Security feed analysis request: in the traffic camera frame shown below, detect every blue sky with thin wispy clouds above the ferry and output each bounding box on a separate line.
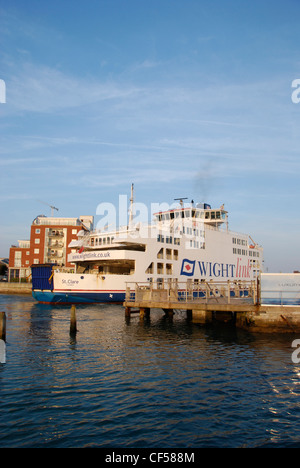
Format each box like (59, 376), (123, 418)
(0, 0), (300, 272)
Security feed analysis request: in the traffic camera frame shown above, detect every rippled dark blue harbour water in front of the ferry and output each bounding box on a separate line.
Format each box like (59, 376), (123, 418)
(0, 295), (300, 449)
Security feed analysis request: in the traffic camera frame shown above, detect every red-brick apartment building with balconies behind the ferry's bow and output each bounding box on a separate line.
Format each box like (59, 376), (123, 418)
(9, 215), (93, 281)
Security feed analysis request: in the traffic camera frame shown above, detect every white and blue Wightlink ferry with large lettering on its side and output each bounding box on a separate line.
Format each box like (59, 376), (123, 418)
(32, 188), (263, 304)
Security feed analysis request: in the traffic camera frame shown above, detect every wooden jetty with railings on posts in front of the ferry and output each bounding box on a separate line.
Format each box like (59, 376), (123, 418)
(124, 280), (300, 333)
